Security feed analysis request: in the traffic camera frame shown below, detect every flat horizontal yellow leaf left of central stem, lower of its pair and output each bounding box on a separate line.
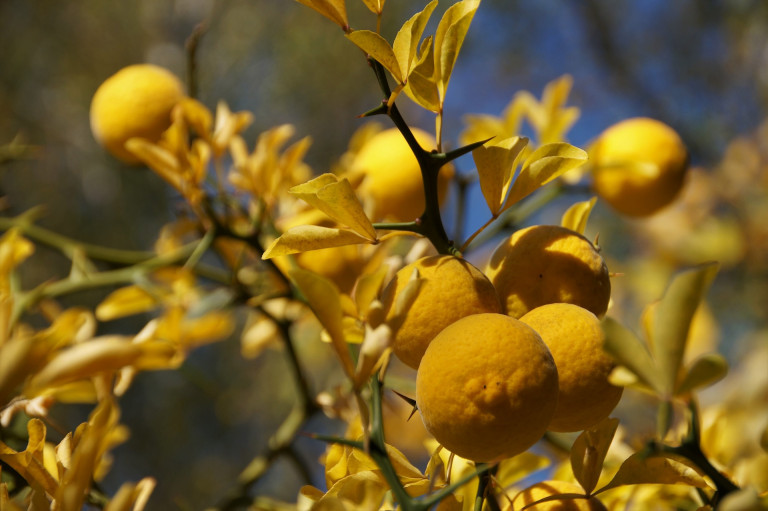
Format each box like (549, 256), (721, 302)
(261, 225), (370, 259)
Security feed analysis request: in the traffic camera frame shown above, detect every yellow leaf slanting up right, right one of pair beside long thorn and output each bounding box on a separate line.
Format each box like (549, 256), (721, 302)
(503, 142), (587, 209)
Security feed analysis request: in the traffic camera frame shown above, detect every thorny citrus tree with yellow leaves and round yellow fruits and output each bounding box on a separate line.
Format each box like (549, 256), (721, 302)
(0, 0), (768, 510)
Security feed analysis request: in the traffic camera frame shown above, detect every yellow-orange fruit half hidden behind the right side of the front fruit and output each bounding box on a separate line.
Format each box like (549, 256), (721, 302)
(520, 303), (624, 432)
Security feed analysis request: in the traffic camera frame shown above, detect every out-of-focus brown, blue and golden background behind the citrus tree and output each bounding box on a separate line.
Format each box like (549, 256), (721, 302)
(0, 0), (768, 509)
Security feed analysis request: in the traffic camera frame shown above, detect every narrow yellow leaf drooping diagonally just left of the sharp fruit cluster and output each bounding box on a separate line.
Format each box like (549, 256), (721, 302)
(289, 269), (355, 378)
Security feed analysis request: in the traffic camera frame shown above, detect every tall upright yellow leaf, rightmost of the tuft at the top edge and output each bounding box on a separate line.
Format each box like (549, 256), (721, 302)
(435, 0), (480, 104)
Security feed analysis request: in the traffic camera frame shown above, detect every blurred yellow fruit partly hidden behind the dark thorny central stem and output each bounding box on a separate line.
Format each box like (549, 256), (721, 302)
(352, 128), (453, 222)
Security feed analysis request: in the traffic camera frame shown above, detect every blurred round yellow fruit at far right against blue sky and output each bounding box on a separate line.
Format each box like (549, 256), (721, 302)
(589, 117), (689, 216)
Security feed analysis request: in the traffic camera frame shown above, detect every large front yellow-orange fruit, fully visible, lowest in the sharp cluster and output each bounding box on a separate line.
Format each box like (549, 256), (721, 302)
(416, 313), (557, 462)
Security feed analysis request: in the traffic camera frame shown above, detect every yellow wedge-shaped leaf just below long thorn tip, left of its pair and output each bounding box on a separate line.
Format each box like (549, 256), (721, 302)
(472, 137), (528, 216)
